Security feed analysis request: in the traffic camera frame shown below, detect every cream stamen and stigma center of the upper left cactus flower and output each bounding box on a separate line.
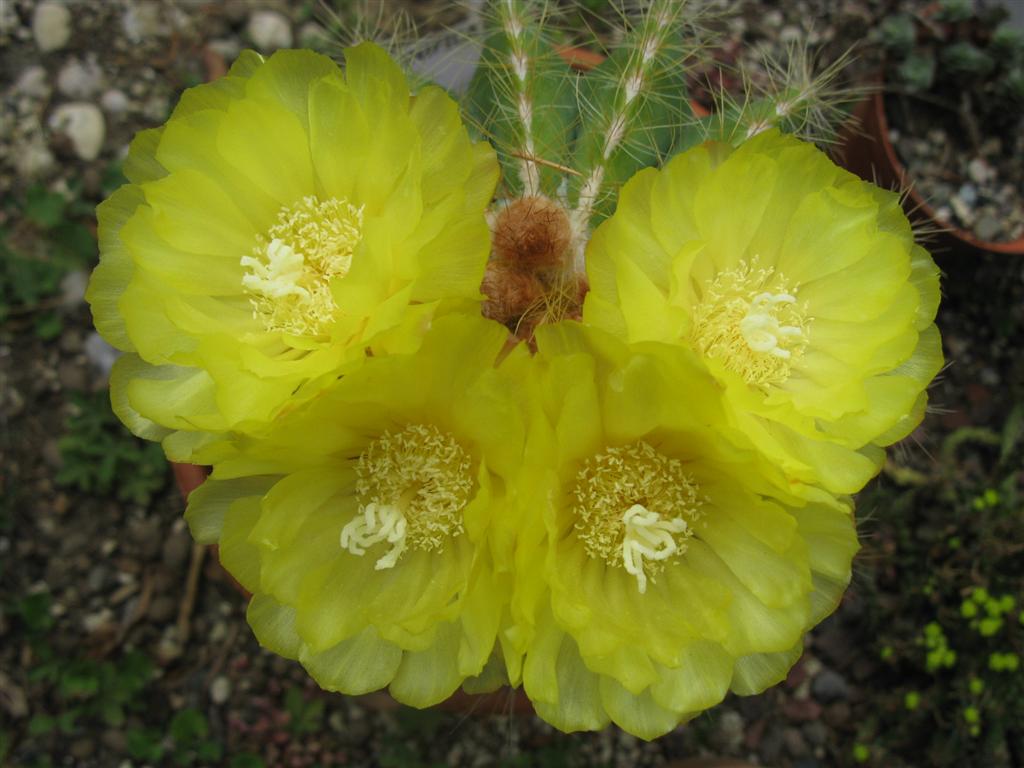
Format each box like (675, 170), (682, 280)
(241, 196), (362, 336)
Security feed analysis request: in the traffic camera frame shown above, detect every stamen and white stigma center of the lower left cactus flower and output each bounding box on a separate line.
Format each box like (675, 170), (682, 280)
(341, 424), (473, 570)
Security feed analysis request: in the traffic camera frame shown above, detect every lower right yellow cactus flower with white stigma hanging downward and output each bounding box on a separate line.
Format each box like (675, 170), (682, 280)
(509, 323), (858, 739)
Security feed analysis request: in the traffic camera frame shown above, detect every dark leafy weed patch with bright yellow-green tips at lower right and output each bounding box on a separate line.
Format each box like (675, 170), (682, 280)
(861, 404), (1024, 765)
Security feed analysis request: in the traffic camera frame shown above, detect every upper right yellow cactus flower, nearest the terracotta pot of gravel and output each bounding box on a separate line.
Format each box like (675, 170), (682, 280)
(584, 131), (942, 494)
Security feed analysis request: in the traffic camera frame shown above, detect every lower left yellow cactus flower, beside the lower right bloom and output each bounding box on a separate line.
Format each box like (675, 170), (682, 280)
(185, 314), (526, 707)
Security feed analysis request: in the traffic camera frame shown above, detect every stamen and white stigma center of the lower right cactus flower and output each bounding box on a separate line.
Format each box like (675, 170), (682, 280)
(572, 440), (702, 594)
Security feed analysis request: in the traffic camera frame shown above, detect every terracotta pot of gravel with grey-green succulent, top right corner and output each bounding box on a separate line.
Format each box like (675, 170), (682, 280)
(847, 0), (1024, 262)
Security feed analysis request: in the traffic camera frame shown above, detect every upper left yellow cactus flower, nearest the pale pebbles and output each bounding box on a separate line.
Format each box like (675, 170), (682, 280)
(88, 43), (498, 450)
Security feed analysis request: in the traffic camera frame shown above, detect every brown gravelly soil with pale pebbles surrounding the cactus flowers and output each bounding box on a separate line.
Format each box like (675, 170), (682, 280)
(0, 0), (1024, 768)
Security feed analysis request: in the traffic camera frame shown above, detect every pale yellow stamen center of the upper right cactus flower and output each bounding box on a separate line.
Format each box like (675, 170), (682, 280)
(692, 257), (810, 386)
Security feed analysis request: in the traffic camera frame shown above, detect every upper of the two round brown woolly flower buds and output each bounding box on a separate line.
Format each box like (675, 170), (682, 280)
(494, 196), (571, 272)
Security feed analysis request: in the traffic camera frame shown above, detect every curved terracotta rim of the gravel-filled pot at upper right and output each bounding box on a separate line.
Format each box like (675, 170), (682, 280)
(840, 91), (1024, 273)
